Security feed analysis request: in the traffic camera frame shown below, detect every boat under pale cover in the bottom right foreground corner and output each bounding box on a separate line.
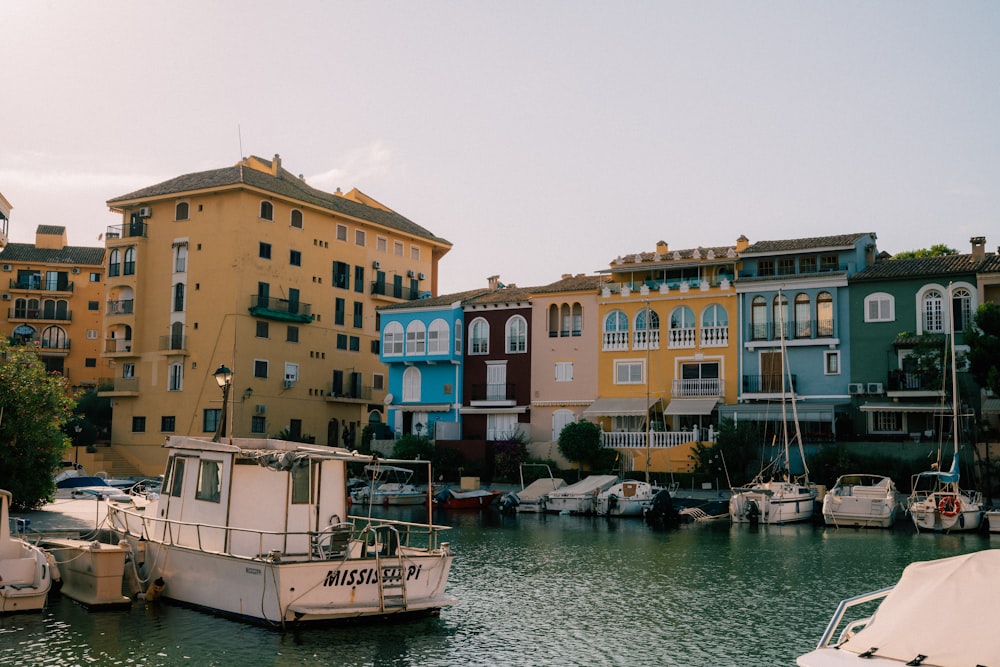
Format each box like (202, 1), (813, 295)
(796, 549), (1000, 667)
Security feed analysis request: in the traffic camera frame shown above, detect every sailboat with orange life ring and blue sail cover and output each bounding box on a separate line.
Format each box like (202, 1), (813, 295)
(906, 288), (983, 531)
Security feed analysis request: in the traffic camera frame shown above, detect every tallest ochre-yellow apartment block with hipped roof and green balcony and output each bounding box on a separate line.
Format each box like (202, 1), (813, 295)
(102, 155), (451, 474)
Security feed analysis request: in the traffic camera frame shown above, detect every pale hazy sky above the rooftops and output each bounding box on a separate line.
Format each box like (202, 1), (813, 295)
(0, 0), (1000, 293)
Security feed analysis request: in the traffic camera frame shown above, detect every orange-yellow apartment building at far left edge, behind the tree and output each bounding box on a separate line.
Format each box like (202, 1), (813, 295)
(0, 217), (104, 389)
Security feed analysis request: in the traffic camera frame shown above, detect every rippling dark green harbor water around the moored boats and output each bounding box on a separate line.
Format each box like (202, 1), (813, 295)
(0, 508), (997, 667)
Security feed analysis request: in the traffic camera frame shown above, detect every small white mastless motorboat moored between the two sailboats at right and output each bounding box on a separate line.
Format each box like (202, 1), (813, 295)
(823, 474), (899, 528)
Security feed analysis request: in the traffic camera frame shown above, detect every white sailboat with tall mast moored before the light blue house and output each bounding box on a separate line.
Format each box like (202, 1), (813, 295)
(729, 292), (817, 524)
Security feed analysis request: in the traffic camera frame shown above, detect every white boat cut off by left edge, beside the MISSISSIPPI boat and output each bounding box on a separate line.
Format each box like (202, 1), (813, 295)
(0, 489), (53, 614)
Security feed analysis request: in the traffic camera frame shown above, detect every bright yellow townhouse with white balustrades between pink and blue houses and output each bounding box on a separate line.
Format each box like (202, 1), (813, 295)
(583, 237), (747, 472)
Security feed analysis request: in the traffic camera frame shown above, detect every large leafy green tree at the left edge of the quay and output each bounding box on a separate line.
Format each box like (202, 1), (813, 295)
(0, 339), (73, 509)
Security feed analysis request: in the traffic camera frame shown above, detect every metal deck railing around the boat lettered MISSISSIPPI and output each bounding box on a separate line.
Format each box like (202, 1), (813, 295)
(108, 507), (450, 562)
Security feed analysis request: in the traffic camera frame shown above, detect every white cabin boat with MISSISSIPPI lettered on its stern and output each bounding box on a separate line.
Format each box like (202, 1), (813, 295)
(108, 436), (455, 627)
